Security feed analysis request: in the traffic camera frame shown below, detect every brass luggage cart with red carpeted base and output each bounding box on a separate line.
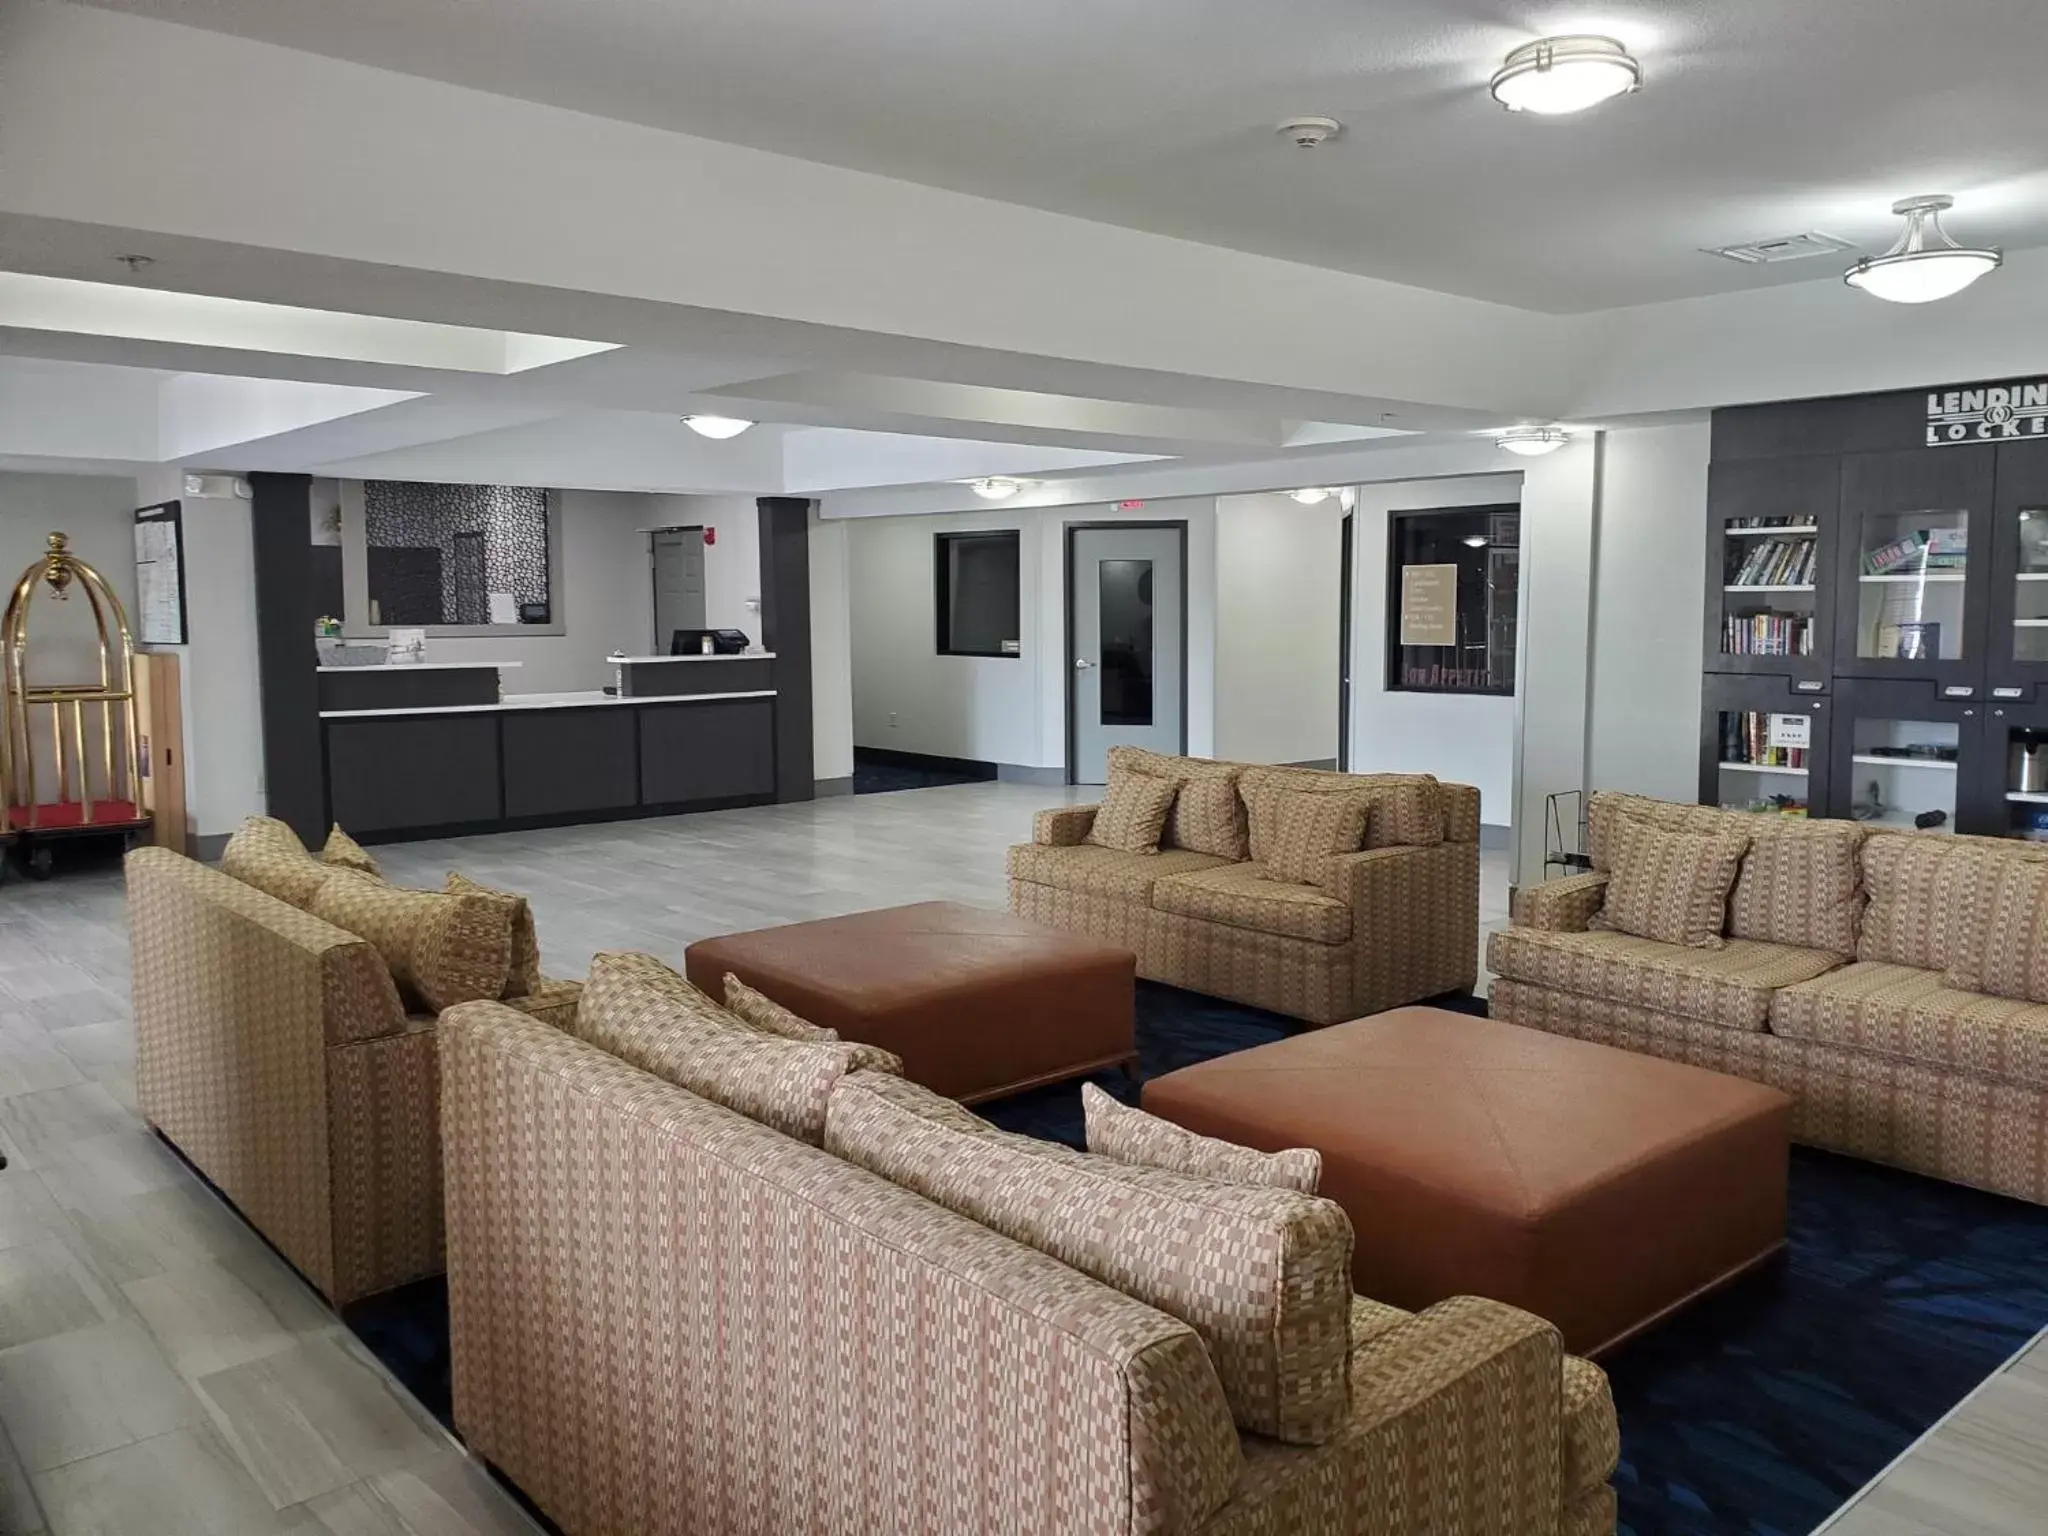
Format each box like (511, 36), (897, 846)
(0, 532), (150, 879)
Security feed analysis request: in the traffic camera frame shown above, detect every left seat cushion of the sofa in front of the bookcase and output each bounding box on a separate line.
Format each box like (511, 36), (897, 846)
(1487, 928), (1841, 1030)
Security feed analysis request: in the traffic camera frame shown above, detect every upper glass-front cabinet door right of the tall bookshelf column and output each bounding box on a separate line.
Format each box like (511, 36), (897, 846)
(1835, 446), (1995, 698)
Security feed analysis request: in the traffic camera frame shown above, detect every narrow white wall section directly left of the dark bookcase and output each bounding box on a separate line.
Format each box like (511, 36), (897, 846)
(1587, 422), (1710, 801)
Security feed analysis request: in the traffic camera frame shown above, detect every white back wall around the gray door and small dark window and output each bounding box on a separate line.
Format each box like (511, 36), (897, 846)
(844, 496), (1217, 770)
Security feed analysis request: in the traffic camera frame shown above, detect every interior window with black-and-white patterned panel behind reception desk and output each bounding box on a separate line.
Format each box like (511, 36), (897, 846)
(362, 479), (551, 625)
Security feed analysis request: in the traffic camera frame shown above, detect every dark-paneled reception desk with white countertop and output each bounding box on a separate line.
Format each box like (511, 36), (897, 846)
(319, 655), (776, 842)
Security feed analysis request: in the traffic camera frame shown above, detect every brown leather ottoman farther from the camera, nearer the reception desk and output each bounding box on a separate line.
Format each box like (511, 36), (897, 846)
(684, 901), (1137, 1104)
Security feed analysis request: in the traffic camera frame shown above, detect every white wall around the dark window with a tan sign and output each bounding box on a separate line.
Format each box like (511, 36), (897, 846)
(1352, 473), (1532, 827)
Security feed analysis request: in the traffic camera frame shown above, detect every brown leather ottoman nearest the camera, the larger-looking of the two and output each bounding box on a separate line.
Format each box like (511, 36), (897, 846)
(1143, 1008), (1792, 1354)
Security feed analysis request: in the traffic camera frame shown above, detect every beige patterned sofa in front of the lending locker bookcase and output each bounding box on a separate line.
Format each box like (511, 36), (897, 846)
(1487, 795), (2048, 1202)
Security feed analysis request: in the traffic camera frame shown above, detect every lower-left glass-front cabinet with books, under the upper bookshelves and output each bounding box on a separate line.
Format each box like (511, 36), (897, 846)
(1700, 676), (1833, 815)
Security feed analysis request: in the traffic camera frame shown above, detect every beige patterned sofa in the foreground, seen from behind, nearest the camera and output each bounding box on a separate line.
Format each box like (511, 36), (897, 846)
(440, 974), (1618, 1536)
